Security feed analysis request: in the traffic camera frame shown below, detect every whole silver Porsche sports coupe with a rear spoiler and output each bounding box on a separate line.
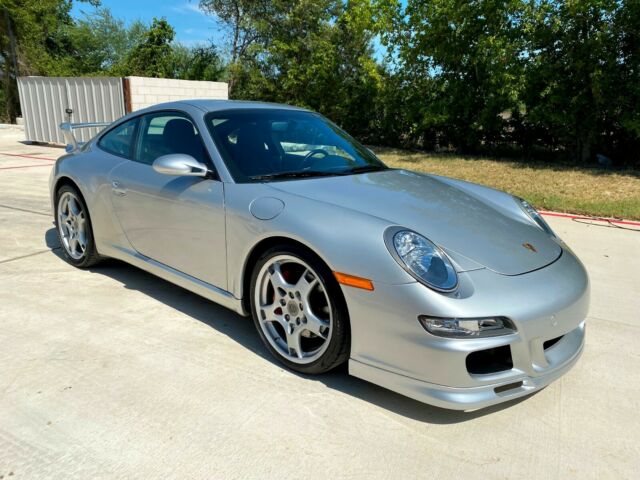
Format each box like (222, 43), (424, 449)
(50, 100), (589, 410)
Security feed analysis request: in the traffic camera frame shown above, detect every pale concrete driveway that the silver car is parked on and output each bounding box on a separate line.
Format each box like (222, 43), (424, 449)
(0, 131), (640, 480)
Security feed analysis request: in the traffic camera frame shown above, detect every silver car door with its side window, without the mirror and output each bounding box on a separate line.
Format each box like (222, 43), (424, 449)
(105, 111), (227, 290)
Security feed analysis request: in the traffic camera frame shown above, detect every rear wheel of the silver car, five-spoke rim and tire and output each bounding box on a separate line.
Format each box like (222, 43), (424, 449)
(55, 185), (100, 268)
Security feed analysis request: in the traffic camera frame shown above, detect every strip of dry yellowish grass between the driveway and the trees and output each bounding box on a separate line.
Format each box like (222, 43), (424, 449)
(373, 147), (640, 220)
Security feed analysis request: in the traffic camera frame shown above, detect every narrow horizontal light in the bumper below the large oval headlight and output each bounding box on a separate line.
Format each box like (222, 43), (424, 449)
(418, 315), (516, 338)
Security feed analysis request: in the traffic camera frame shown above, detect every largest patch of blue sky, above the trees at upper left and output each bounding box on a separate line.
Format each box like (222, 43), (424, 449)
(71, 0), (224, 46)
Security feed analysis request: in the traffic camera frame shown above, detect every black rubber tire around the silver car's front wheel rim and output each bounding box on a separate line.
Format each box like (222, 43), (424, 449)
(248, 245), (351, 375)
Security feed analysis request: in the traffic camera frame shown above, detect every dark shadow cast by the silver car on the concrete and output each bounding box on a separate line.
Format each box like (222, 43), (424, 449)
(45, 229), (528, 424)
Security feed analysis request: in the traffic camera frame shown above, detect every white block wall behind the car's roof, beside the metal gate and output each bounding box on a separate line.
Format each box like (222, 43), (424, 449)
(128, 77), (229, 111)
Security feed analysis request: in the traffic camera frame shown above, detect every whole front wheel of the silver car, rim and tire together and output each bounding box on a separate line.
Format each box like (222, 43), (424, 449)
(250, 246), (350, 374)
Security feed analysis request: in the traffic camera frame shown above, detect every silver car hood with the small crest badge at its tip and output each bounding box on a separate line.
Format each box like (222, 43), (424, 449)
(270, 170), (562, 275)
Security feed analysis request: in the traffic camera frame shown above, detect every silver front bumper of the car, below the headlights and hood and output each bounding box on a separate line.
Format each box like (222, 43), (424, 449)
(343, 250), (589, 410)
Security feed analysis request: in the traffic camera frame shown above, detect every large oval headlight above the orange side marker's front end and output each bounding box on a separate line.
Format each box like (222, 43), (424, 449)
(385, 228), (458, 292)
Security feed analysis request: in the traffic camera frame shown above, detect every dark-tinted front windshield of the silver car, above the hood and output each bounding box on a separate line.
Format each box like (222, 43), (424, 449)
(206, 109), (387, 182)
